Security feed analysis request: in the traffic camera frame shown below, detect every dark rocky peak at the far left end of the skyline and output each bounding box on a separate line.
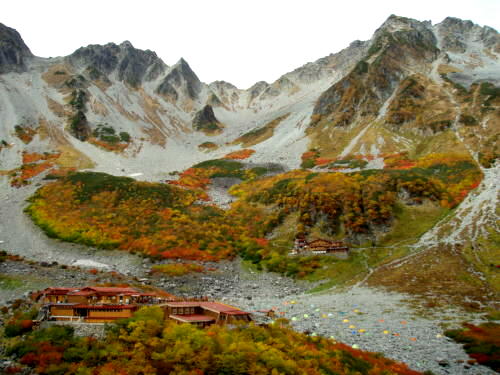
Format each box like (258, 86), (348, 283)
(0, 23), (33, 74)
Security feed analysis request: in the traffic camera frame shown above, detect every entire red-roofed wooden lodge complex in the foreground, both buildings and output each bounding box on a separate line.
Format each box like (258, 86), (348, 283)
(33, 287), (252, 327)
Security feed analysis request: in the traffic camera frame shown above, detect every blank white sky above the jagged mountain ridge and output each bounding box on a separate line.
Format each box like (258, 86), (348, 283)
(0, 0), (500, 88)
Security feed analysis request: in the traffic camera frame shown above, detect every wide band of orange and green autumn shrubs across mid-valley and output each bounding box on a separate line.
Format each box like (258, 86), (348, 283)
(26, 154), (482, 277)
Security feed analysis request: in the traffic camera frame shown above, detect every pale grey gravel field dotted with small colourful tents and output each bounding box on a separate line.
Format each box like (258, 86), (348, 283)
(231, 286), (494, 375)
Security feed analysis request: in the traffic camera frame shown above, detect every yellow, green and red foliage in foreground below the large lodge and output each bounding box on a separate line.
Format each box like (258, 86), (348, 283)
(5, 307), (420, 375)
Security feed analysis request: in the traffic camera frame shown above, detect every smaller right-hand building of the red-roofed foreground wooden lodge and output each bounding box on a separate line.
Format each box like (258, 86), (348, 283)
(161, 301), (252, 327)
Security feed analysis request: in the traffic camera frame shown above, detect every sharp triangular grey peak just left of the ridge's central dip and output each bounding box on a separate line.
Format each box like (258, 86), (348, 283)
(156, 58), (202, 101)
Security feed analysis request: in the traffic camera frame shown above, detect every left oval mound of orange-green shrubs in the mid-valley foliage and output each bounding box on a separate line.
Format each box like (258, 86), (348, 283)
(26, 172), (261, 261)
